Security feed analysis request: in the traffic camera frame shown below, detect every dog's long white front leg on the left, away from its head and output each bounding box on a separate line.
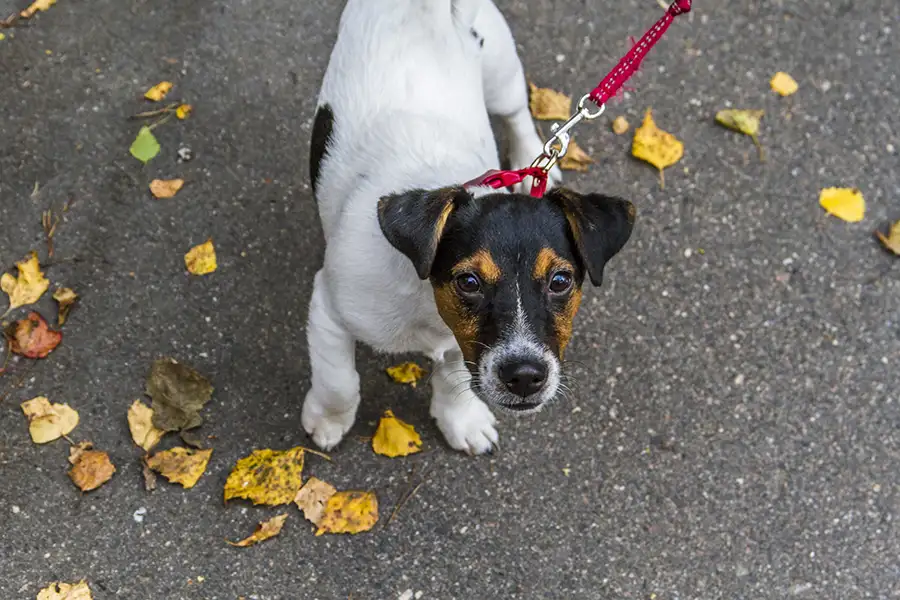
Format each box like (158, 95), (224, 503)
(302, 271), (359, 450)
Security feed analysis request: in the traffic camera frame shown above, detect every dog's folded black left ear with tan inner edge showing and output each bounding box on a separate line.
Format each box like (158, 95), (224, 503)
(378, 187), (472, 279)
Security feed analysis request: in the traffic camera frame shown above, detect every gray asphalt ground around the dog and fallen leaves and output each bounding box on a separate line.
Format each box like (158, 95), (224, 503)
(0, 0), (900, 600)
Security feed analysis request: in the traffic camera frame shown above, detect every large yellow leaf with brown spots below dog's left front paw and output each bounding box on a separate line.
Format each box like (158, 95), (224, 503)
(225, 446), (303, 506)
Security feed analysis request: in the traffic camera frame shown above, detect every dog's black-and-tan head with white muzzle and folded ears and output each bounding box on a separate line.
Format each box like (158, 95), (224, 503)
(378, 187), (634, 413)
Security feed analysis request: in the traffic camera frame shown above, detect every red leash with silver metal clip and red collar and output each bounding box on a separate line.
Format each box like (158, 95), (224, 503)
(464, 0), (691, 198)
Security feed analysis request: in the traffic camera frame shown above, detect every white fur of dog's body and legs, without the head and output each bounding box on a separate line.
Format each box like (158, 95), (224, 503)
(303, 0), (558, 454)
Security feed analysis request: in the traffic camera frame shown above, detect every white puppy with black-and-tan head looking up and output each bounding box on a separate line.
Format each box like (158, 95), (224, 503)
(302, 0), (635, 454)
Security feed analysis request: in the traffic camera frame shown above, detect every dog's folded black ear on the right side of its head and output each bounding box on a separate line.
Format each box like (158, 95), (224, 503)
(546, 188), (635, 286)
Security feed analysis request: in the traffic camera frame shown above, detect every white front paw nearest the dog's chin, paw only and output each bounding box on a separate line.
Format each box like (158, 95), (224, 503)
(431, 394), (500, 454)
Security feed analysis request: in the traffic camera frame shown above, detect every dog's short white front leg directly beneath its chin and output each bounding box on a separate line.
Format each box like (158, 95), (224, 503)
(431, 351), (499, 454)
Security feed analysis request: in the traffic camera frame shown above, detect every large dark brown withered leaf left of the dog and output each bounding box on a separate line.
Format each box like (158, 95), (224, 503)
(147, 358), (213, 431)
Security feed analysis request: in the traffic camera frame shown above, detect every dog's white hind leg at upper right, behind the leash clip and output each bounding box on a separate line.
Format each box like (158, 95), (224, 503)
(467, 0), (562, 187)
